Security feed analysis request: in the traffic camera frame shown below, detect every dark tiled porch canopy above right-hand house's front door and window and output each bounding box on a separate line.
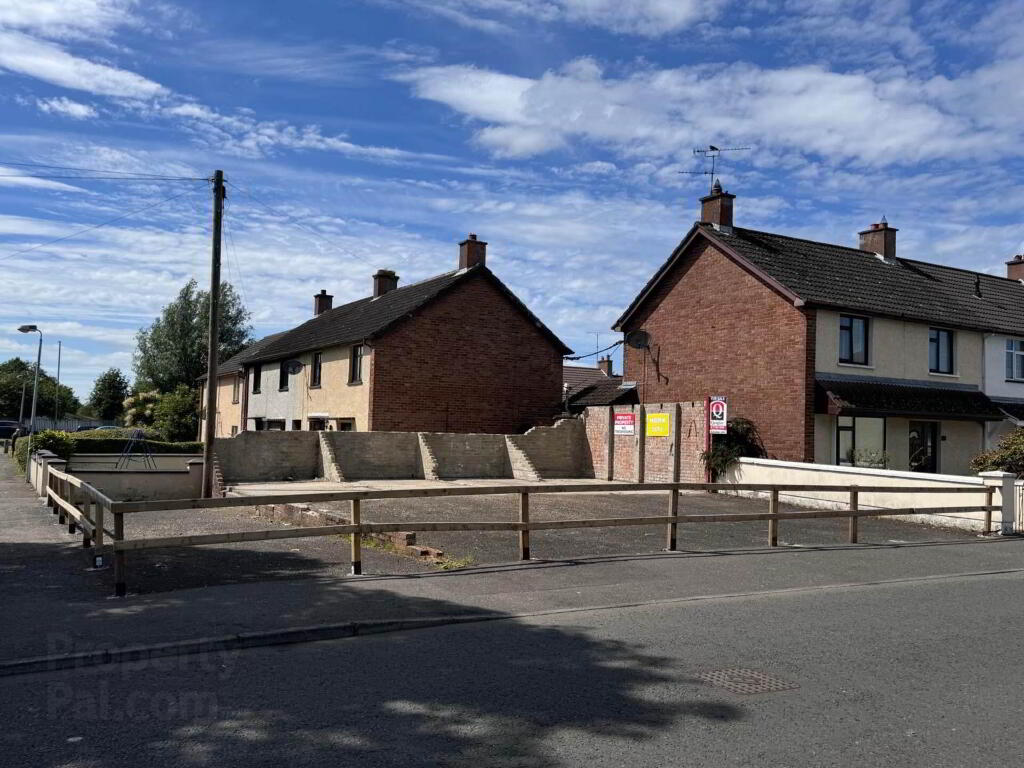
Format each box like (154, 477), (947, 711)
(814, 377), (1007, 421)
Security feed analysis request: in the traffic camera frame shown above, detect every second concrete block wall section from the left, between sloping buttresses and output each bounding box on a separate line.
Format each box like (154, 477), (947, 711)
(325, 432), (424, 480)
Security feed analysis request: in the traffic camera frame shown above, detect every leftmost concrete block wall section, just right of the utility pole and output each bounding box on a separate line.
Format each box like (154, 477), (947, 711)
(213, 431), (323, 482)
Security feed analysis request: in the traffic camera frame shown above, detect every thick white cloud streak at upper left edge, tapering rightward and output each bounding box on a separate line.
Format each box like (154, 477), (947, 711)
(0, 31), (166, 98)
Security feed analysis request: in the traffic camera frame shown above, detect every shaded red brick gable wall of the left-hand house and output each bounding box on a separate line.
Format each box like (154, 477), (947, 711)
(370, 274), (562, 433)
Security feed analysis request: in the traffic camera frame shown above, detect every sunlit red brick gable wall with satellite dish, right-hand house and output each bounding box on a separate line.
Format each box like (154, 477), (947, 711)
(625, 240), (814, 461)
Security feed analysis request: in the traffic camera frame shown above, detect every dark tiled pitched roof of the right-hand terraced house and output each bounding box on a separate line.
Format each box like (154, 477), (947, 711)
(615, 219), (1024, 334)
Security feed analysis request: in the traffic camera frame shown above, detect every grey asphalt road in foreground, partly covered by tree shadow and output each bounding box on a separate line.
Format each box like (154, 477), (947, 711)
(6, 572), (1024, 768)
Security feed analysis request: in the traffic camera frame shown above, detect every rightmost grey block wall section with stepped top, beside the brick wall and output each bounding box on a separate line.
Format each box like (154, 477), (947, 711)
(505, 419), (594, 480)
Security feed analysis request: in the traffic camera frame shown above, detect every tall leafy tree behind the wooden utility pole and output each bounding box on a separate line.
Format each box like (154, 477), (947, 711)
(134, 280), (252, 392)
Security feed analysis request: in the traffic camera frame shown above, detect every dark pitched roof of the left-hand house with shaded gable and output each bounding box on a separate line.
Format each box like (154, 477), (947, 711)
(244, 264), (572, 362)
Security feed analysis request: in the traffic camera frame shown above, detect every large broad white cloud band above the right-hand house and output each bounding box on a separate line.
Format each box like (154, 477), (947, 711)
(400, 59), (1024, 165)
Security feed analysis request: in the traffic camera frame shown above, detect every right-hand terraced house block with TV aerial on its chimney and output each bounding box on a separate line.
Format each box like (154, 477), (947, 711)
(614, 181), (1024, 473)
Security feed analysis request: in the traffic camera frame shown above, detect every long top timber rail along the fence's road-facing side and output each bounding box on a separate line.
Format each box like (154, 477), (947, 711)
(114, 482), (986, 514)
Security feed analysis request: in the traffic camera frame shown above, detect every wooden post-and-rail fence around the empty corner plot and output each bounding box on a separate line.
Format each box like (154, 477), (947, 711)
(25, 450), (1000, 596)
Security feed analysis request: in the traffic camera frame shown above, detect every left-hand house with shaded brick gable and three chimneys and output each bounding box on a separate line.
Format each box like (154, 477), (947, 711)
(211, 234), (571, 433)
